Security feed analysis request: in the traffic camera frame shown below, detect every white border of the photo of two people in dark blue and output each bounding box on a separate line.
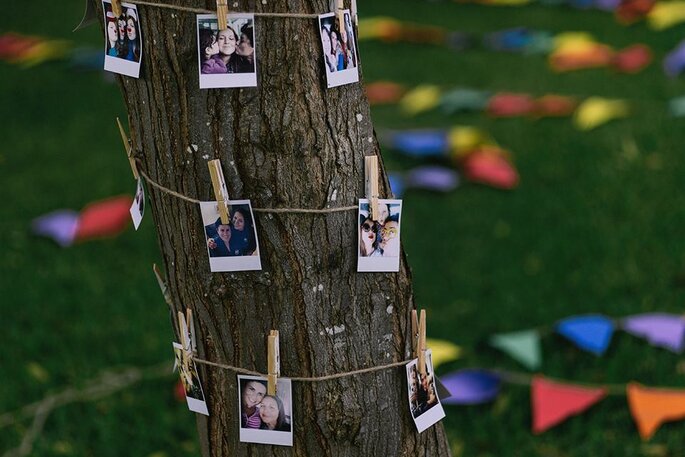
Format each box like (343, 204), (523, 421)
(200, 200), (262, 272)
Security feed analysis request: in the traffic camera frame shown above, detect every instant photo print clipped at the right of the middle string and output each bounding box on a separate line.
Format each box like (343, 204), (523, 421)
(357, 199), (402, 272)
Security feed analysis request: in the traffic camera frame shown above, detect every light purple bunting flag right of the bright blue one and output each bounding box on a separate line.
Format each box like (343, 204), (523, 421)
(621, 313), (685, 354)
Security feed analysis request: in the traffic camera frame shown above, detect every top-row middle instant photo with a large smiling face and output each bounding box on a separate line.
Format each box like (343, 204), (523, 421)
(197, 14), (257, 89)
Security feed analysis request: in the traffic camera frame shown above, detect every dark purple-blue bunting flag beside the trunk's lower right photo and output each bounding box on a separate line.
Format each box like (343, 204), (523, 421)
(440, 368), (501, 405)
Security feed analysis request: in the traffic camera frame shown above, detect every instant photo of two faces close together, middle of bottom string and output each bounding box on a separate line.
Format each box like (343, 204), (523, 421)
(238, 376), (293, 446)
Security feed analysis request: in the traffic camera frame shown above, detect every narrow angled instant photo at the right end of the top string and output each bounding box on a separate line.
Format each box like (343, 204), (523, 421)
(319, 10), (359, 87)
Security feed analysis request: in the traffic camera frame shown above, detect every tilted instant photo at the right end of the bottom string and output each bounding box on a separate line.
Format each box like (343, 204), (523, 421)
(407, 349), (445, 433)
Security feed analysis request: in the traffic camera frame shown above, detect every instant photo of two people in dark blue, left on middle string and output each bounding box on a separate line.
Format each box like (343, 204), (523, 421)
(200, 200), (262, 272)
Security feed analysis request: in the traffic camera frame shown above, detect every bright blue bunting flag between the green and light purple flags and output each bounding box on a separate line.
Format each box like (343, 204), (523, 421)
(556, 315), (614, 355)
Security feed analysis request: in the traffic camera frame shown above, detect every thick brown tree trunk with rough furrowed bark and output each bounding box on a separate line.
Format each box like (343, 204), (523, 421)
(101, 0), (449, 456)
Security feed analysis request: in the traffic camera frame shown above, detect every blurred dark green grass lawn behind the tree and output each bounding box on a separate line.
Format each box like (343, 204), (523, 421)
(0, 0), (685, 457)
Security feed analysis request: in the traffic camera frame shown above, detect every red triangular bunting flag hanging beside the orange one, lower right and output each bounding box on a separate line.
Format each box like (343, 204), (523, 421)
(530, 376), (607, 434)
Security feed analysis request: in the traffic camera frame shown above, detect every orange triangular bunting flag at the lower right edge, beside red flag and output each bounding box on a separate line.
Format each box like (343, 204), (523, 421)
(626, 382), (685, 440)
